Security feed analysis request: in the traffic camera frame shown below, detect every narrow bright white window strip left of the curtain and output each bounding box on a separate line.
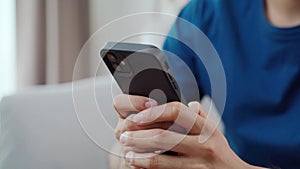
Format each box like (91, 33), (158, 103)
(0, 0), (16, 100)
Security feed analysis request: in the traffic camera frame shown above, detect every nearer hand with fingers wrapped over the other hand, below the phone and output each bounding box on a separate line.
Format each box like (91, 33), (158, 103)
(120, 102), (264, 169)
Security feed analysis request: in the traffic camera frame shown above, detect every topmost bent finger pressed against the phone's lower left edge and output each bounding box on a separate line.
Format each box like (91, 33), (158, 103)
(113, 94), (157, 118)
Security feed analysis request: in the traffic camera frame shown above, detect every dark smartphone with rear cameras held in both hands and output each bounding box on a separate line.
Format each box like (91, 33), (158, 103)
(100, 42), (184, 104)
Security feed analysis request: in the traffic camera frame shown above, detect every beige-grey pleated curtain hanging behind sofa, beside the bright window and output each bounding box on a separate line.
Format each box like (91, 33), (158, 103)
(16, 0), (89, 88)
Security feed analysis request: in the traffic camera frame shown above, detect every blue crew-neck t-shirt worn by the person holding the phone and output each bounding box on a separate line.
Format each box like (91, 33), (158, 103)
(164, 0), (300, 169)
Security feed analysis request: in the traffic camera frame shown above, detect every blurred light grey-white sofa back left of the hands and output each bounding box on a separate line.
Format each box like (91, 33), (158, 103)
(0, 77), (118, 169)
